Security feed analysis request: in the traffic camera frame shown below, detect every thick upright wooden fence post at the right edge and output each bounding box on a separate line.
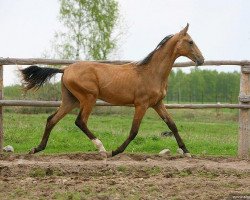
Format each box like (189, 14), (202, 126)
(238, 65), (250, 158)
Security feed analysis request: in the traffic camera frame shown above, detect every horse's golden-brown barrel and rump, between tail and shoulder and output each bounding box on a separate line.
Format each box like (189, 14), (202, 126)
(63, 62), (138, 104)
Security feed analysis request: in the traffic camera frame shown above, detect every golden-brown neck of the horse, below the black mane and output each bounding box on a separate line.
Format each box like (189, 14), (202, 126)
(148, 38), (178, 82)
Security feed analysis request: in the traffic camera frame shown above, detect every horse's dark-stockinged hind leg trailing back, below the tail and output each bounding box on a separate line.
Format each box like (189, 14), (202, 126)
(29, 84), (78, 154)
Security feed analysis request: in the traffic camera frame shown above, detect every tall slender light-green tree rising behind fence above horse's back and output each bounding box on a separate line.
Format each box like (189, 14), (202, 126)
(51, 0), (119, 60)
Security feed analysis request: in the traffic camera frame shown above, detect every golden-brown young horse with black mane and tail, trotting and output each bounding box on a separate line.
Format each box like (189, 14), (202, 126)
(20, 24), (204, 158)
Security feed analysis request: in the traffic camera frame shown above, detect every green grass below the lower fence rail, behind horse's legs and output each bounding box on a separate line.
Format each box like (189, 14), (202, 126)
(4, 108), (238, 156)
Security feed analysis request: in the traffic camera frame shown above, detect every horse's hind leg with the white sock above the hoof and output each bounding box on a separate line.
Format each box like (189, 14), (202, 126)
(75, 95), (107, 157)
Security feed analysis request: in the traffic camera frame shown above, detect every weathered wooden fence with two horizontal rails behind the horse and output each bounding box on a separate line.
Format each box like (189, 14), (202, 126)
(0, 58), (250, 158)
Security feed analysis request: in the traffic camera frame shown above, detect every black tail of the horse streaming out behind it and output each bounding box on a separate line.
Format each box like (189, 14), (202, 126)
(20, 65), (63, 90)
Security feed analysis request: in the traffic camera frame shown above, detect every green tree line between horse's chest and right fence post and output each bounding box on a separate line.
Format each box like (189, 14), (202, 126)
(166, 68), (240, 103)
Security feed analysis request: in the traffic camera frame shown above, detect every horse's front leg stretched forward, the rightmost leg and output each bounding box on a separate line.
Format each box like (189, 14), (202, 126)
(153, 102), (191, 157)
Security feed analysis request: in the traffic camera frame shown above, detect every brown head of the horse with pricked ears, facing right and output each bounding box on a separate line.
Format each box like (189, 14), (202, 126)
(176, 24), (204, 66)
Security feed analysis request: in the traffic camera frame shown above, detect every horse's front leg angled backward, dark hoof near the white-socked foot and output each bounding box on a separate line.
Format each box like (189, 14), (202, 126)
(112, 105), (148, 156)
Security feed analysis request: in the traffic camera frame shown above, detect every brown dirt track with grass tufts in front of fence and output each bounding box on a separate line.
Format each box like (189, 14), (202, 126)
(0, 154), (250, 199)
